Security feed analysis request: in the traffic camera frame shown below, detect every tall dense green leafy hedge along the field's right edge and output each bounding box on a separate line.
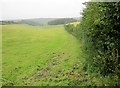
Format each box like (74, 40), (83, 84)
(65, 2), (120, 75)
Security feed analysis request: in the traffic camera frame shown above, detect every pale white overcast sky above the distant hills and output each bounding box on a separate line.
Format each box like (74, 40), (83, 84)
(0, 0), (89, 20)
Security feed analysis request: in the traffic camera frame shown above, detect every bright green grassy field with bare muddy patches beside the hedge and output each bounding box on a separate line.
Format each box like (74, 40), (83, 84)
(2, 25), (85, 86)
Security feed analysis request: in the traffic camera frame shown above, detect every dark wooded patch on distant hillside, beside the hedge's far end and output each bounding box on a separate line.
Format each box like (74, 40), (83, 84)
(48, 18), (77, 25)
